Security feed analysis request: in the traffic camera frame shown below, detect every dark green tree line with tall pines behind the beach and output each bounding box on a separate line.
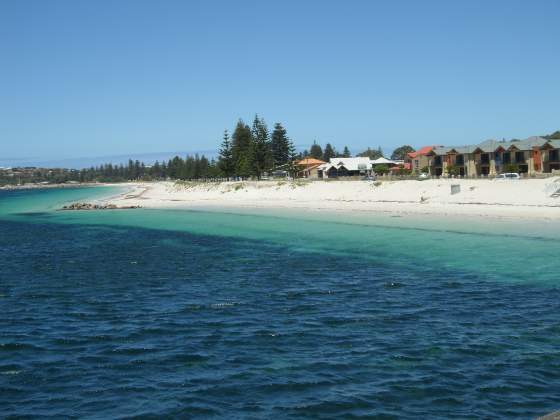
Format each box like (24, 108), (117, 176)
(10, 110), (524, 184)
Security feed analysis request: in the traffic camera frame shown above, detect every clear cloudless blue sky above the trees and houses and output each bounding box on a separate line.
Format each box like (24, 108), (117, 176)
(0, 0), (560, 166)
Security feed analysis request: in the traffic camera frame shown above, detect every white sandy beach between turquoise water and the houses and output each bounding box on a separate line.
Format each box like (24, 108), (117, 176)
(100, 177), (560, 220)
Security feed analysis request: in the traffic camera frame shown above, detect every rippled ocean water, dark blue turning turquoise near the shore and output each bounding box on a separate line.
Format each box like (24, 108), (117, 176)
(0, 188), (560, 418)
